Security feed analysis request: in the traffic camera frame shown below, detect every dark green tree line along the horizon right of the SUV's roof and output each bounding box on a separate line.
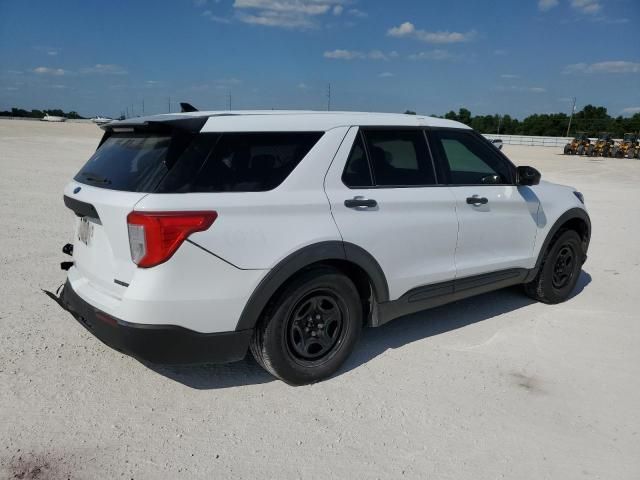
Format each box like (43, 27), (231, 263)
(412, 105), (640, 138)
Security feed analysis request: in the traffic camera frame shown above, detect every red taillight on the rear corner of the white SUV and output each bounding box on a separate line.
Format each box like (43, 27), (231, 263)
(127, 212), (218, 268)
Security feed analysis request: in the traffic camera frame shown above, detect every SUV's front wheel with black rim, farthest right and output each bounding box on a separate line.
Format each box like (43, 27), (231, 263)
(524, 230), (584, 304)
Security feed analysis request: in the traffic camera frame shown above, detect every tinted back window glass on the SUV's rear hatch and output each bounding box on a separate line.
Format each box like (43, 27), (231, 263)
(75, 133), (171, 192)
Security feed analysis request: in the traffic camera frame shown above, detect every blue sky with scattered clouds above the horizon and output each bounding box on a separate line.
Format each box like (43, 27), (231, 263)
(0, 0), (640, 117)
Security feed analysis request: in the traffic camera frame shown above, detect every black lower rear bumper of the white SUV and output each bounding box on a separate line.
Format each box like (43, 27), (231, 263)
(59, 281), (253, 364)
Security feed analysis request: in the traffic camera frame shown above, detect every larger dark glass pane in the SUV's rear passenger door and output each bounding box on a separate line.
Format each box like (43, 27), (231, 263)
(363, 129), (436, 186)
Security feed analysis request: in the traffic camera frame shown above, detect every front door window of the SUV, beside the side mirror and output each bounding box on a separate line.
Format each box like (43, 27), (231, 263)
(432, 130), (512, 185)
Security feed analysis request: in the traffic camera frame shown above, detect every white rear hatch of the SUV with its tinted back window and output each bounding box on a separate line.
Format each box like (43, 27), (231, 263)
(64, 120), (204, 298)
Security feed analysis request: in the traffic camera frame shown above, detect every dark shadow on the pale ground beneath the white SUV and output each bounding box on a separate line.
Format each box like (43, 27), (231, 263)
(145, 271), (591, 390)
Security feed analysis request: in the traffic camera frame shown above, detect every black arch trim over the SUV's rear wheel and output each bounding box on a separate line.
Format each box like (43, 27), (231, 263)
(236, 240), (389, 331)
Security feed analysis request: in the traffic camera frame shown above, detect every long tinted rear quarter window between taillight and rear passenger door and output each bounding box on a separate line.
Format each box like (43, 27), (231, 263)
(182, 132), (322, 192)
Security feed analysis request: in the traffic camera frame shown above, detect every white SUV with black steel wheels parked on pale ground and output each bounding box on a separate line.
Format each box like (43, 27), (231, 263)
(59, 112), (591, 384)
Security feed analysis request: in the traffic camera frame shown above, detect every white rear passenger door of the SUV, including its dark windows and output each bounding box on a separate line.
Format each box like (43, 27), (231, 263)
(325, 127), (458, 300)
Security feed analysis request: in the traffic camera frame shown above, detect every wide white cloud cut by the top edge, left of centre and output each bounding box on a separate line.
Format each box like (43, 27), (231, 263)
(233, 0), (347, 29)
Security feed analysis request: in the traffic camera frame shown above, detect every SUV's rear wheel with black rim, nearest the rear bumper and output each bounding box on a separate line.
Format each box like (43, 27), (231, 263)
(250, 267), (363, 385)
